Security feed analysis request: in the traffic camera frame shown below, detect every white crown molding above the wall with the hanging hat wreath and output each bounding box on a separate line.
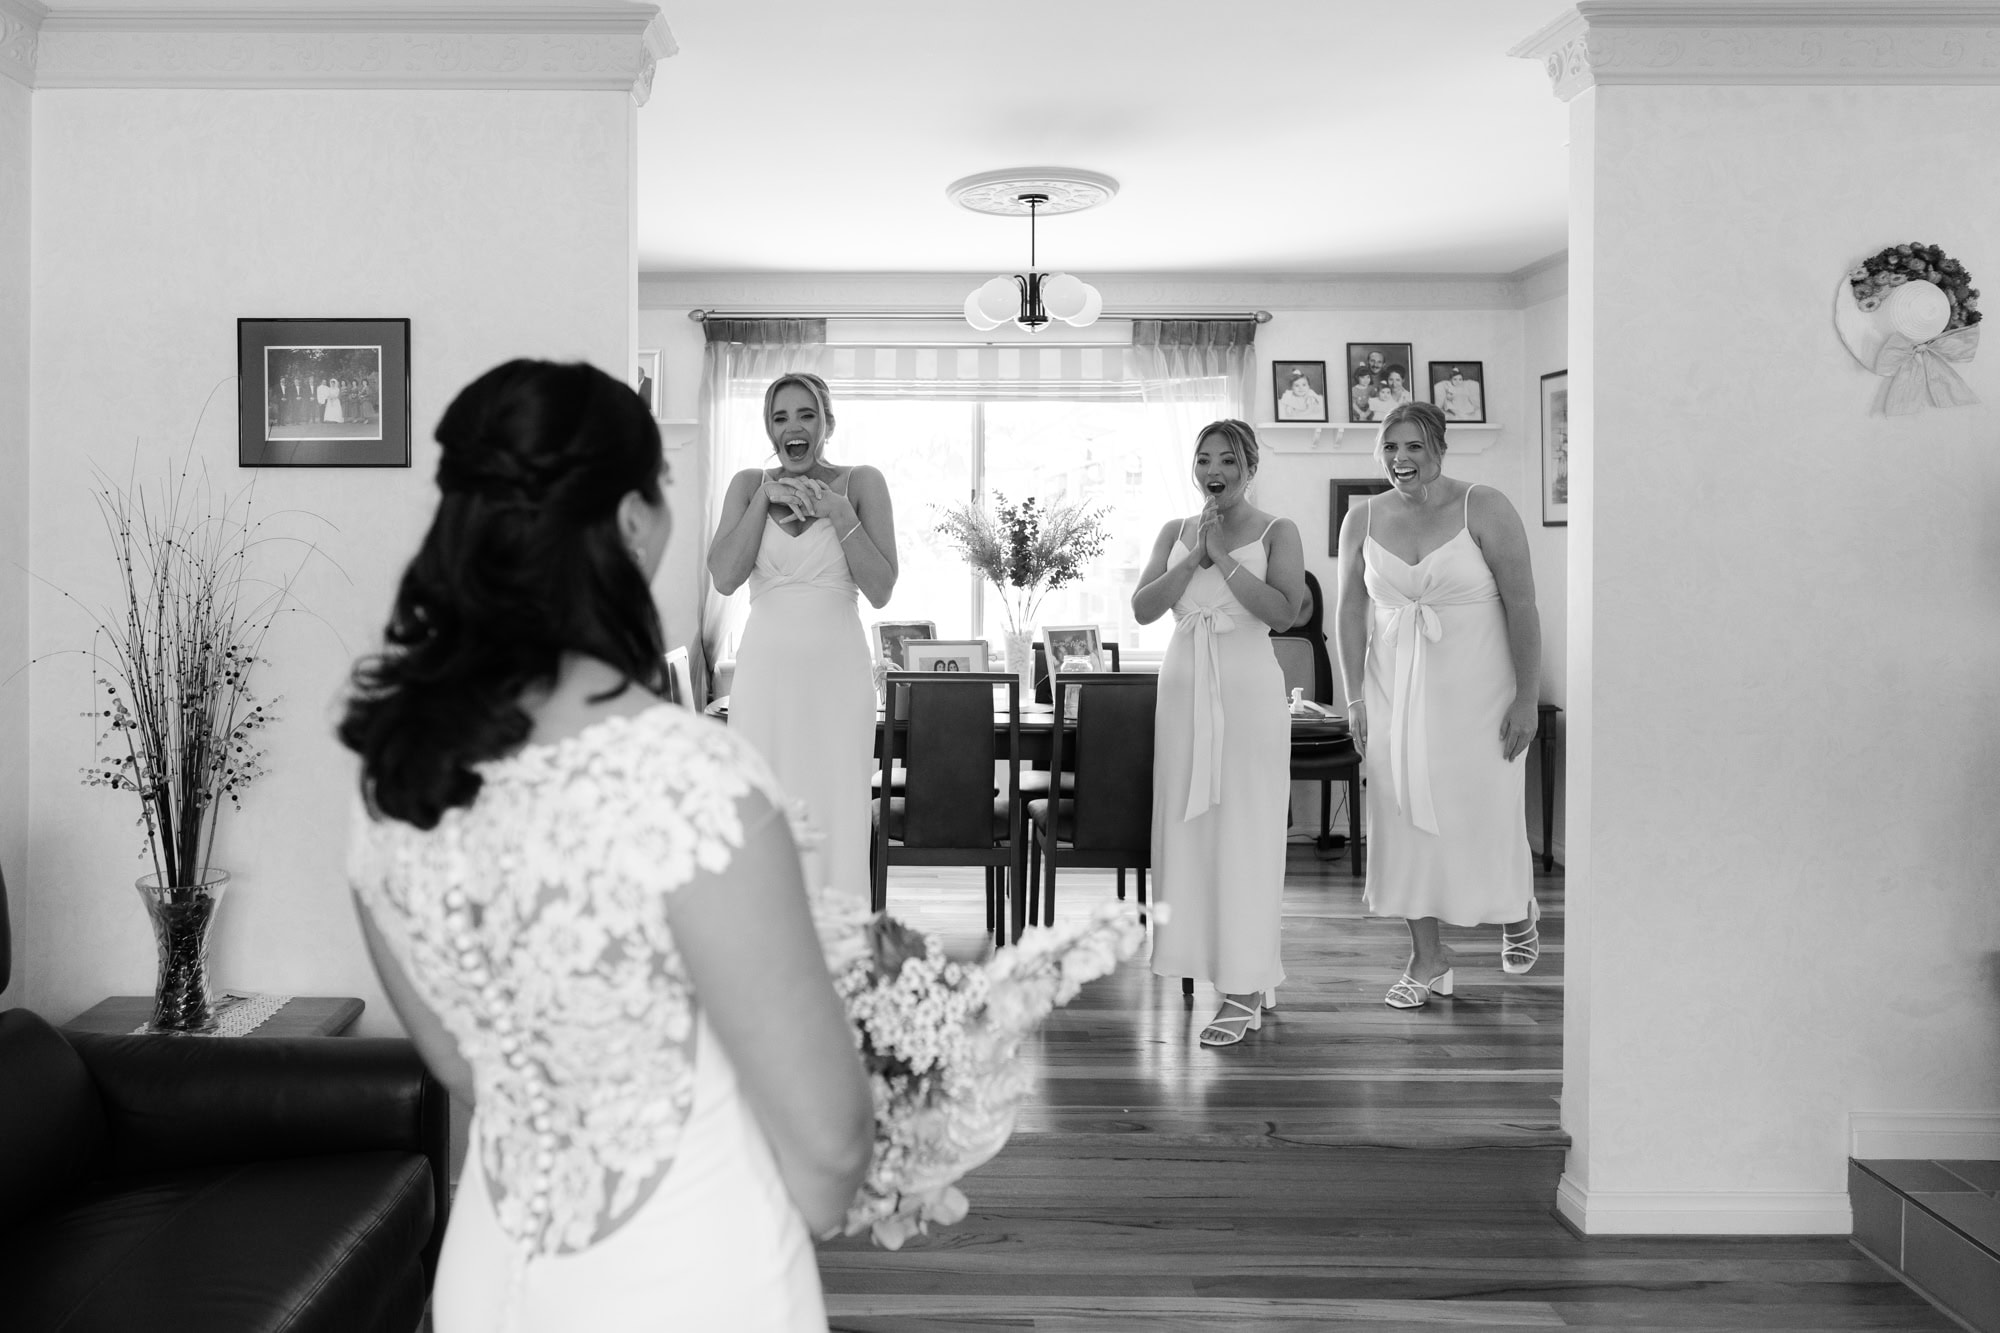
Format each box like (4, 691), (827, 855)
(1508, 0), (2000, 102)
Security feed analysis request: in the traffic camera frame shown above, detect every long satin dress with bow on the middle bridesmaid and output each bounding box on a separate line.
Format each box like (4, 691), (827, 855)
(1152, 524), (1292, 995)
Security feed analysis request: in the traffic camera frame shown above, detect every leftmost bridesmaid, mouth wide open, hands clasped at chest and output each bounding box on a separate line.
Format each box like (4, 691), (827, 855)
(708, 374), (896, 903)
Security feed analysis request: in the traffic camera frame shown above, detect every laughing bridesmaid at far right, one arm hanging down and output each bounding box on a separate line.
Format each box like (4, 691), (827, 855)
(1334, 402), (1542, 1009)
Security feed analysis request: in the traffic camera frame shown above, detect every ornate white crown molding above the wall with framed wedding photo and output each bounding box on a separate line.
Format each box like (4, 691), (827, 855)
(27, 0), (678, 106)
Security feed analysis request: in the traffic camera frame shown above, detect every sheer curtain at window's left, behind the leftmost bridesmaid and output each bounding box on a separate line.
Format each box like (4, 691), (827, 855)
(690, 318), (826, 696)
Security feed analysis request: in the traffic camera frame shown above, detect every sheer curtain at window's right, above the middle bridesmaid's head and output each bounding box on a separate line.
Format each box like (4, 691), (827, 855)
(1132, 320), (1256, 516)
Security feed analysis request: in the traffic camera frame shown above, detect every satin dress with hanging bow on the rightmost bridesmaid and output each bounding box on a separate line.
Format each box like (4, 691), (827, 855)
(1362, 488), (1534, 925)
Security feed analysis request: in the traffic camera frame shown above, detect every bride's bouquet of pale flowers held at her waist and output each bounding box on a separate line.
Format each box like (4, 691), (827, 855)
(818, 899), (1160, 1249)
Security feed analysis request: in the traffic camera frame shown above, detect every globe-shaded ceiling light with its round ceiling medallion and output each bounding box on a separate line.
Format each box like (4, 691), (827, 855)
(946, 168), (1118, 332)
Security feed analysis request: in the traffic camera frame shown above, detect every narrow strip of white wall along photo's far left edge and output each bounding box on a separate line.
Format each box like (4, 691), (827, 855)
(0, 74), (32, 999)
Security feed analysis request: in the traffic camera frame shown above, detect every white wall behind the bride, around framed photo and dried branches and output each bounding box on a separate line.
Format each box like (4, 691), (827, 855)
(27, 88), (636, 1033)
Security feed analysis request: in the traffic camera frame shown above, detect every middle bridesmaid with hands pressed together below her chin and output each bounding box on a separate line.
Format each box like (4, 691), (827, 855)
(1132, 420), (1306, 1047)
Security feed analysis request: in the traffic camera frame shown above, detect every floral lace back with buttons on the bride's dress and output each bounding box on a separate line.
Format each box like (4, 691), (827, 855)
(348, 705), (782, 1255)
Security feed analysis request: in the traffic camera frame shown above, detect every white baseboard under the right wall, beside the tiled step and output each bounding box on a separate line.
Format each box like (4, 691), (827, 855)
(1556, 1173), (1854, 1235)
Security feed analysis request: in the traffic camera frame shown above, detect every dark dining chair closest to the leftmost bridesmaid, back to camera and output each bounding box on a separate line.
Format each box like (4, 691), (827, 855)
(868, 671), (1026, 945)
